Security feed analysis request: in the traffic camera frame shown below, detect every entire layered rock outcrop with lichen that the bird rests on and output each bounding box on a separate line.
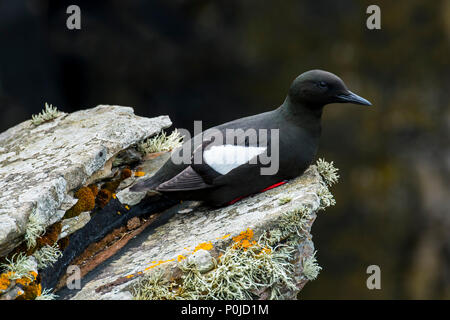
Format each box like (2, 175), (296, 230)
(0, 106), (337, 299)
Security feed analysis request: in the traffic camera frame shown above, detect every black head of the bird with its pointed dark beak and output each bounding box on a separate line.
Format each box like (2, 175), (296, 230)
(289, 70), (372, 107)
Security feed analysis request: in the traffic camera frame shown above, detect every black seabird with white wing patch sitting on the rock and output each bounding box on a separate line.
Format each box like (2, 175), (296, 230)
(130, 69), (372, 207)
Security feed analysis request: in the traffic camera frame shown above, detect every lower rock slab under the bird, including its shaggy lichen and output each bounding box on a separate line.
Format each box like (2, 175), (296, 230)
(60, 166), (332, 299)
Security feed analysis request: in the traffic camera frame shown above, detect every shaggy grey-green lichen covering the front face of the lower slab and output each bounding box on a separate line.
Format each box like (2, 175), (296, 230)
(131, 159), (339, 300)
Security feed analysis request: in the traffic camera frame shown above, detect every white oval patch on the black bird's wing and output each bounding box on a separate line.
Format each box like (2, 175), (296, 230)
(203, 144), (266, 174)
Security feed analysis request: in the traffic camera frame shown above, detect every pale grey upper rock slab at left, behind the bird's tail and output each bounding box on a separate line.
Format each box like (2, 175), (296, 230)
(0, 105), (171, 256)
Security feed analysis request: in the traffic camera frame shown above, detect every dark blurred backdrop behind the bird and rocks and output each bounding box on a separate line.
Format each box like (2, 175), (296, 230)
(0, 0), (450, 299)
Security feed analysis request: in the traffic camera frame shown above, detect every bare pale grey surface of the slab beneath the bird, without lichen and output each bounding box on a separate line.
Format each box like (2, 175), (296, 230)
(66, 166), (324, 300)
